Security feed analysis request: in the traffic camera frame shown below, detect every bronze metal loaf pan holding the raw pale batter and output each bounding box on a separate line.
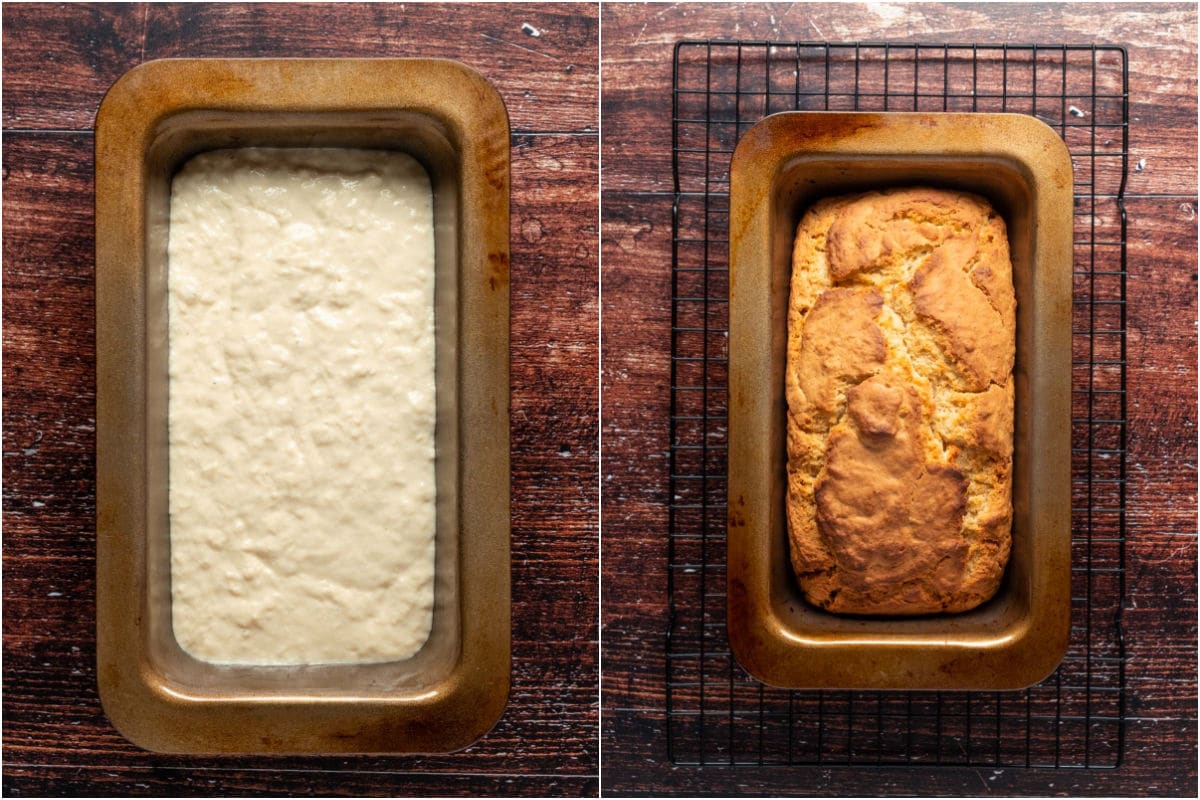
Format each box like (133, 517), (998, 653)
(96, 59), (511, 753)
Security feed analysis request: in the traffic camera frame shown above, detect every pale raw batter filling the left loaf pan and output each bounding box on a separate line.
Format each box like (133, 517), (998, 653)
(168, 149), (436, 664)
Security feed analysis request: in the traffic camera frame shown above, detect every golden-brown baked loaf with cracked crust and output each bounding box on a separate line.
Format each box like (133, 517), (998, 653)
(787, 187), (1016, 614)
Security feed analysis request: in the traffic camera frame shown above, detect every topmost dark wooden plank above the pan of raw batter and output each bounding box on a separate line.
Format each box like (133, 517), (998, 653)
(4, 4), (599, 132)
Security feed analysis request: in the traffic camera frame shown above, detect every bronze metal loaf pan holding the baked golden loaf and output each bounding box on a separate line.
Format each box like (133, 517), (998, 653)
(727, 112), (1073, 690)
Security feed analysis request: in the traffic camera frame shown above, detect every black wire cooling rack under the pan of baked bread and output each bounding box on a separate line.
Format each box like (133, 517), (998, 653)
(667, 41), (1129, 768)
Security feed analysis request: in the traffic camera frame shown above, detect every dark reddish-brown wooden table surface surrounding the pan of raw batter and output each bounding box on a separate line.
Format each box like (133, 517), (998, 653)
(4, 4), (599, 796)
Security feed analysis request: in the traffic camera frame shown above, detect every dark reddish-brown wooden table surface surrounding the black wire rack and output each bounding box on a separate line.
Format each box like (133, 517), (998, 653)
(601, 2), (1196, 796)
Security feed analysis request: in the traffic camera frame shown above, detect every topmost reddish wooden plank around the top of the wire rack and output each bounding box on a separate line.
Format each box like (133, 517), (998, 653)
(602, 2), (1196, 193)
